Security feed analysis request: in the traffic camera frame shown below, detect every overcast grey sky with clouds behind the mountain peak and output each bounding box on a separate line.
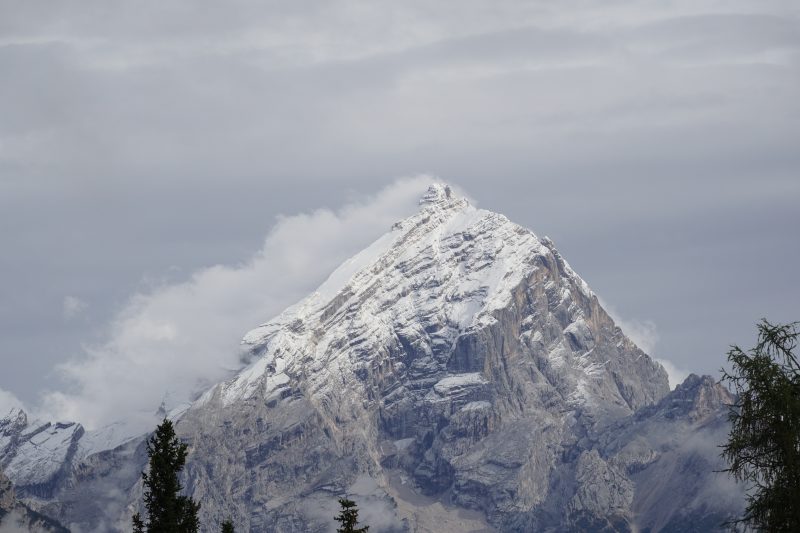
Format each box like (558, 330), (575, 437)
(0, 0), (800, 426)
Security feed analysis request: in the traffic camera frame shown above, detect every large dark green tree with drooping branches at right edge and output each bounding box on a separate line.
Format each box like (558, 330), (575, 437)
(722, 320), (800, 531)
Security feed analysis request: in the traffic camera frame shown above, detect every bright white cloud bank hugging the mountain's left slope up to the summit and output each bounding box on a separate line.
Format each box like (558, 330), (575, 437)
(43, 176), (440, 429)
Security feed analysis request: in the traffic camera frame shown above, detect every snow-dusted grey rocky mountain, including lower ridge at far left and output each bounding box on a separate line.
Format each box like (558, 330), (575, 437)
(0, 185), (742, 532)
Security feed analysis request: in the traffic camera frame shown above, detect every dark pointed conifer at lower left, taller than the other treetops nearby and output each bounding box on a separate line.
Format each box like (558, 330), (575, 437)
(133, 418), (200, 533)
